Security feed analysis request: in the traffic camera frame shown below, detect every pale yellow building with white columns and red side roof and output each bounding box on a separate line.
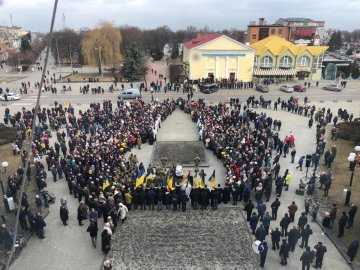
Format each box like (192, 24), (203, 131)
(183, 33), (255, 82)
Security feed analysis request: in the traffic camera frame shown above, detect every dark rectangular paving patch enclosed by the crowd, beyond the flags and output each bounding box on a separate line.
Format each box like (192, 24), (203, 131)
(151, 141), (208, 167)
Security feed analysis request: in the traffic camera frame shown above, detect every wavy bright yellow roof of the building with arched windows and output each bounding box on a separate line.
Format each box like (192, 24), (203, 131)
(250, 36), (329, 56)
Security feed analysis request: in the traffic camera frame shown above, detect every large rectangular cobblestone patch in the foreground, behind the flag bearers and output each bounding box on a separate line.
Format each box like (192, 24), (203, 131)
(108, 208), (258, 270)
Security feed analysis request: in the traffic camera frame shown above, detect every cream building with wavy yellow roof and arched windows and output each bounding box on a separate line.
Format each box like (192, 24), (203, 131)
(251, 36), (329, 81)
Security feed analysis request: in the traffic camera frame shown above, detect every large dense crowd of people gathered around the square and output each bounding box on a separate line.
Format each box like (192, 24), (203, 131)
(1, 89), (358, 268)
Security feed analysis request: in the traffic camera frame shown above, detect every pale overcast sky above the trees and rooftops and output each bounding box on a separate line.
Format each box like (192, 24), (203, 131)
(0, 0), (360, 32)
